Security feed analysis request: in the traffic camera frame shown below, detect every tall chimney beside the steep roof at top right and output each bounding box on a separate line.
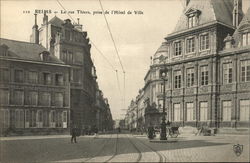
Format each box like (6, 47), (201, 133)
(233, 0), (243, 28)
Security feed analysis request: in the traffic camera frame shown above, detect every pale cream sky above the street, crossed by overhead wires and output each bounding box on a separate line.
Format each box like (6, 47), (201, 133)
(0, 0), (250, 119)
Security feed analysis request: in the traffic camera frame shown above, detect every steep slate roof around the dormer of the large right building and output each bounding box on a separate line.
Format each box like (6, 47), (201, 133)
(173, 0), (234, 33)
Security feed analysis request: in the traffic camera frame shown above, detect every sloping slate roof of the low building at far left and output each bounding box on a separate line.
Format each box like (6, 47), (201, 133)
(0, 38), (64, 64)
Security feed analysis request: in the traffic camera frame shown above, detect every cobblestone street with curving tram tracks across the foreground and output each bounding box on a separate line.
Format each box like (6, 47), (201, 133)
(0, 134), (249, 162)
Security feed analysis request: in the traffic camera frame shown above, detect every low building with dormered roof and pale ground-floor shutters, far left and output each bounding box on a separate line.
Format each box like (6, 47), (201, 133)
(0, 39), (70, 135)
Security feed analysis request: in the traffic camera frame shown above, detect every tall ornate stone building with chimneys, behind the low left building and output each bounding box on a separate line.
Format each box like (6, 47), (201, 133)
(31, 14), (99, 131)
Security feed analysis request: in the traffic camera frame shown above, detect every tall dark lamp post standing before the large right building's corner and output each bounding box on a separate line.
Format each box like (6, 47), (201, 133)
(160, 69), (167, 140)
